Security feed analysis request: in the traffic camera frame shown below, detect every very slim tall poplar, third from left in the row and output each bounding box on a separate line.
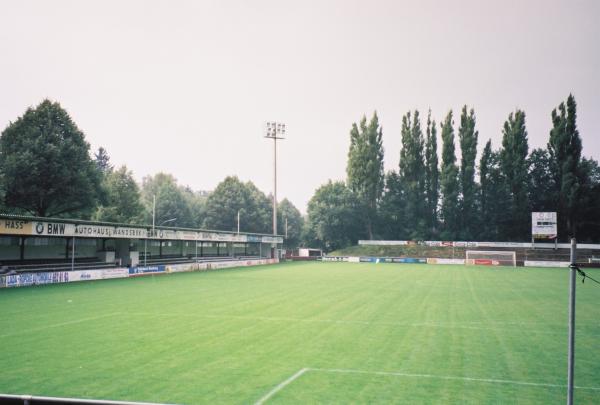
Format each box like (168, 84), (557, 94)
(425, 110), (440, 236)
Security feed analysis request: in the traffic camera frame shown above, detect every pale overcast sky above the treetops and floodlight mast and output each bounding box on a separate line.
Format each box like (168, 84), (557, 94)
(0, 0), (600, 212)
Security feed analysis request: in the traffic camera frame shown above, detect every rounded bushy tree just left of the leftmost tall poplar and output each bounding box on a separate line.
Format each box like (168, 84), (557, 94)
(307, 180), (364, 252)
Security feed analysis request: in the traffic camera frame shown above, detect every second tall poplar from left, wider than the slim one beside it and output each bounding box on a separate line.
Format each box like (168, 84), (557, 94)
(398, 111), (426, 240)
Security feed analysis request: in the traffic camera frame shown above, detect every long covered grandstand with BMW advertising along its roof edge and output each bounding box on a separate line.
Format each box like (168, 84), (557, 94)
(0, 214), (283, 274)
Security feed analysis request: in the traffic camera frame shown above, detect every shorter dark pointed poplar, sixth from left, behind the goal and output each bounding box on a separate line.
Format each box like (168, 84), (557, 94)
(475, 140), (509, 241)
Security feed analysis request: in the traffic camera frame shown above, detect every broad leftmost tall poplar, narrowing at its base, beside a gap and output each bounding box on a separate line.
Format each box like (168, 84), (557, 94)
(346, 113), (384, 239)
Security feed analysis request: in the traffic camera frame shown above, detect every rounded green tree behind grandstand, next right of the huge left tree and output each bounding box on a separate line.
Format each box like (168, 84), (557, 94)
(94, 166), (144, 224)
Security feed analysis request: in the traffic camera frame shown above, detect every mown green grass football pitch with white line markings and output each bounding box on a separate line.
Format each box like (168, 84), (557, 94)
(0, 263), (600, 404)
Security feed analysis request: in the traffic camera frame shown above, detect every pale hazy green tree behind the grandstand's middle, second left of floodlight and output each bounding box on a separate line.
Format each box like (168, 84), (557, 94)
(142, 173), (195, 227)
